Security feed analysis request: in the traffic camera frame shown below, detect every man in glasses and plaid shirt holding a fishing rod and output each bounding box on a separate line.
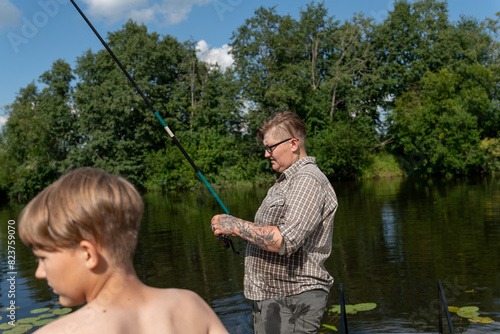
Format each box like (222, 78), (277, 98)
(211, 111), (338, 334)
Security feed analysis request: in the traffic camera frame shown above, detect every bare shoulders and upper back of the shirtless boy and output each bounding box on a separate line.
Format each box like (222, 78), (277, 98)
(31, 287), (227, 334)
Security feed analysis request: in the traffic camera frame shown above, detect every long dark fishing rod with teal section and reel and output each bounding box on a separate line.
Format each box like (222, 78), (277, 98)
(70, 0), (239, 254)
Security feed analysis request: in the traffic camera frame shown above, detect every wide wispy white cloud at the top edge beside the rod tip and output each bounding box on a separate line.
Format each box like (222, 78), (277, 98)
(81, 0), (214, 25)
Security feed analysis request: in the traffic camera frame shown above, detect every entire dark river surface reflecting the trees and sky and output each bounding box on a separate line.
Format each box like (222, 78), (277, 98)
(0, 178), (500, 334)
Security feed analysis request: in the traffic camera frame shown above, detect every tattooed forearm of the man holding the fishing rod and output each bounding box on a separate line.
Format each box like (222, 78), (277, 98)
(220, 216), (278, 250)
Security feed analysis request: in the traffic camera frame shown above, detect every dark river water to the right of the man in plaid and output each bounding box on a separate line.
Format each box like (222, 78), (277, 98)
(327, 179), (500, 333)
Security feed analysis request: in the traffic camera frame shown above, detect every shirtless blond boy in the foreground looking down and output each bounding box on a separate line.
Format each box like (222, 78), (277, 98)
(19, 167), (227, 334)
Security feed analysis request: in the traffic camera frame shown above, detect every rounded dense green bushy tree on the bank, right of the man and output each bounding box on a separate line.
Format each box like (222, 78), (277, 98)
(391, 69), (483, 176)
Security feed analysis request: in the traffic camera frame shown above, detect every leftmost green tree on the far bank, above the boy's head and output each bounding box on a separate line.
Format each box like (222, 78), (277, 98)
(0, 60), (75, 200)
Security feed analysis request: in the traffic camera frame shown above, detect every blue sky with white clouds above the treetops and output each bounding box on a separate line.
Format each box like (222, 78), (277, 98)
(0, 0), (500, 126)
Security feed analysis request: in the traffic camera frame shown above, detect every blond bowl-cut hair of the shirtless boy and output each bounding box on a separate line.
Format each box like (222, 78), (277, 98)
(19, 167), (144, 265)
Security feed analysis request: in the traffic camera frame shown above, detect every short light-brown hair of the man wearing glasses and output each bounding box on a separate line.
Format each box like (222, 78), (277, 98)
(258, 111), (307, 144)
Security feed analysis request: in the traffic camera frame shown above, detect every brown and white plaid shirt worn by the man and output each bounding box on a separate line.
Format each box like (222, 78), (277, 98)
(244, 157), (338, 300)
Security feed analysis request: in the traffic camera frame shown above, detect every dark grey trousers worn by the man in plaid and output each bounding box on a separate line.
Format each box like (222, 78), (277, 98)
(253, 290), (328, 334)
